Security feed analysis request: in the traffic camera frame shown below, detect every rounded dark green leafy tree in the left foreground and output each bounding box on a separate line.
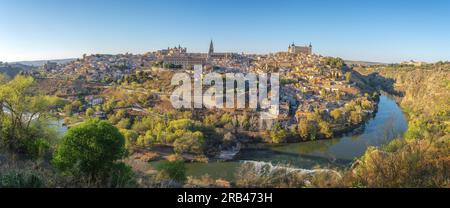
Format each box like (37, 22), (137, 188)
(53, 119), (127, 186)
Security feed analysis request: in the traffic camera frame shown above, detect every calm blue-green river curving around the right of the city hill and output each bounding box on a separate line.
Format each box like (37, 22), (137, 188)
(187, 96), (407, 179)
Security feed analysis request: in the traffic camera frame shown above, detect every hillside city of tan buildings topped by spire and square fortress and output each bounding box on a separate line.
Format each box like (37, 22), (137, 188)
(15, 41), (377, 159)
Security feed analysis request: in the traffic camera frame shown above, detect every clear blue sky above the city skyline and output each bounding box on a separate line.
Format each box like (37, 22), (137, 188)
(0, 0), (450, 63)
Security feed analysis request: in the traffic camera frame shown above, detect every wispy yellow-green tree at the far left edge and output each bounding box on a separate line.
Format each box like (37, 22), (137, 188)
(0, 76), (56, 154)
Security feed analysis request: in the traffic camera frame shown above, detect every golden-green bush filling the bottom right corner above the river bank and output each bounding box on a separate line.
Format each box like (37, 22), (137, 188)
(347, 137), (450, 188)
